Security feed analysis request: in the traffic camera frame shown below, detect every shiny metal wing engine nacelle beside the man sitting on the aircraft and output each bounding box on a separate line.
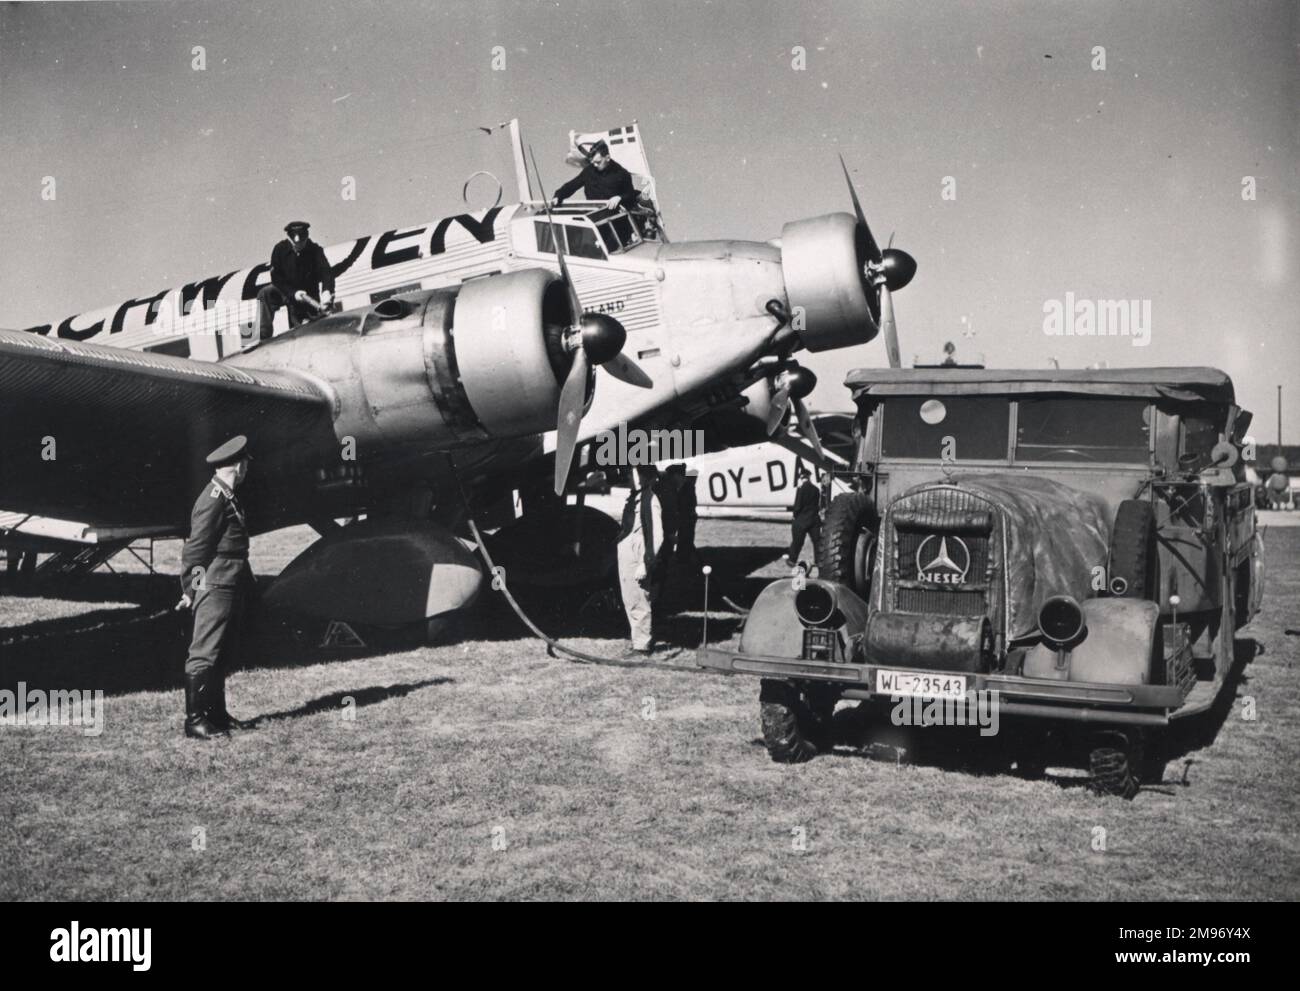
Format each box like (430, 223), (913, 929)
(239, 269), (573, 460)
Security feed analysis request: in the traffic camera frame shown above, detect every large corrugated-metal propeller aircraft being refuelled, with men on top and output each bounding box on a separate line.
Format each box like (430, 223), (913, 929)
(0, 122), (915, 637)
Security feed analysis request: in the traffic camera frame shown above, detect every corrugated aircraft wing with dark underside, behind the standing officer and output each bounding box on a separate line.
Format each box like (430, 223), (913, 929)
(0, 330), (338, 532)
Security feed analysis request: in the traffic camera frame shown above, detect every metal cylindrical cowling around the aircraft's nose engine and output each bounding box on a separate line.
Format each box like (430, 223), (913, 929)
(781, 213), (880, 351)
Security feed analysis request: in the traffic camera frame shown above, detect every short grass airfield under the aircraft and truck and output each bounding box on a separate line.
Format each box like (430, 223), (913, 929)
(0, 522), (1300, 900)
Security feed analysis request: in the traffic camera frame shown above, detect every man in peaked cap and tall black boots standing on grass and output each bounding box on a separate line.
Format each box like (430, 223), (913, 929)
(177, 434), (254, 740)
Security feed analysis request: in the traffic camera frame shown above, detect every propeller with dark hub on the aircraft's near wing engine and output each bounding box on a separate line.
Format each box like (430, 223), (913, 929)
(528, 148), (654, 496)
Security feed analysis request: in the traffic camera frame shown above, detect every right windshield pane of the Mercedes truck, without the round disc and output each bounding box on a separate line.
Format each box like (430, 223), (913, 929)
(1015, 399), (1151, 464)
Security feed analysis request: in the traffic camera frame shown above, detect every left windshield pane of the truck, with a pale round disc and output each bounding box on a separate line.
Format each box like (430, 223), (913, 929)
(880, 395), (1011, 462)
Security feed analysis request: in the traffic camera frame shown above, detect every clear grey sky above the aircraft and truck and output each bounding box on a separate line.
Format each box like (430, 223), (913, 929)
(0, 0), (1300, 442)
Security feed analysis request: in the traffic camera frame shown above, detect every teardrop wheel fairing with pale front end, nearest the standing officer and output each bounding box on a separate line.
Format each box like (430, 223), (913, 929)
(265, 519), (484, 626)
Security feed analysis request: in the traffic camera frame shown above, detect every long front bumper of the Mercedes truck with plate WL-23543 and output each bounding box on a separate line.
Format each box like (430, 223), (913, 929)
(696, 648), (1183, 726)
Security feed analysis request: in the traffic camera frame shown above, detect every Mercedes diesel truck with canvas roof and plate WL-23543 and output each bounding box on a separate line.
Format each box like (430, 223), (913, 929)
(701, 368), (1262, 797)
